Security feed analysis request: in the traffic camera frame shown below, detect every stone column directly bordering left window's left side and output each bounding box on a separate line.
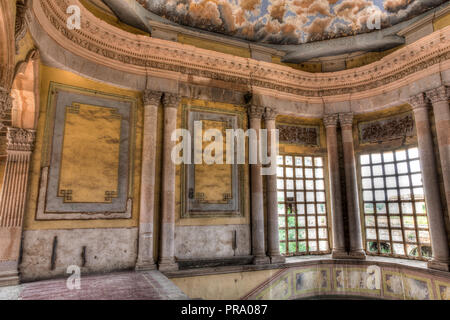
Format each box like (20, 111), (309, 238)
(264, 108), (286, 264)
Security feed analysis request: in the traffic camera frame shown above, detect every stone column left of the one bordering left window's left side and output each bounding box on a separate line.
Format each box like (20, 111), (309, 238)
(248, 106), (270, 264)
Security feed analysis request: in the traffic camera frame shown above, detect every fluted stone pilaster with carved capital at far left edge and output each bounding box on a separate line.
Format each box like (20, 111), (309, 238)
(0, 128), (36, 286)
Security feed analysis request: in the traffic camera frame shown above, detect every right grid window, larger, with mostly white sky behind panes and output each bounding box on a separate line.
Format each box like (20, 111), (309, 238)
(360, 148), (431, 260)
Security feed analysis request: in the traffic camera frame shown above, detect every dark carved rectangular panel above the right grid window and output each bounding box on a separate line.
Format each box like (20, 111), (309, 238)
(359, 113), (414, 143)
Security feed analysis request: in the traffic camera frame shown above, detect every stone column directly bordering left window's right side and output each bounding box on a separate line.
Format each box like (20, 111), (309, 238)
(323, 114), (348, 259)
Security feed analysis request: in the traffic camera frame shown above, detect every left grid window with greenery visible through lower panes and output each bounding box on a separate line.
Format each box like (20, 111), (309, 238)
(277, 155), (330, 256)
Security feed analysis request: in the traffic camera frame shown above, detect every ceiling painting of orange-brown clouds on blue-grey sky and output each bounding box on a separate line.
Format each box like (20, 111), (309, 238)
(137, 0), (447, 44)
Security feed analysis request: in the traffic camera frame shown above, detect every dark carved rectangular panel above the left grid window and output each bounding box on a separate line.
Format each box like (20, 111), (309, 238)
(277, 124), (319, 147)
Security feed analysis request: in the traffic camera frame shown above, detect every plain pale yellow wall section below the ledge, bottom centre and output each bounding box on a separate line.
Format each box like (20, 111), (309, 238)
(171, 269), (280, 300)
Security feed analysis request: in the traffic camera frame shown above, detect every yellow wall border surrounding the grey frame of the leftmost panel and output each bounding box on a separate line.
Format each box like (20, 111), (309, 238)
(24, 65), (143, 230)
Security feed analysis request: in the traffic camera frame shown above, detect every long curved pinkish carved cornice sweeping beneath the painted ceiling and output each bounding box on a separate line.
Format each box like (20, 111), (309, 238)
(33, 0), (450, 98)
